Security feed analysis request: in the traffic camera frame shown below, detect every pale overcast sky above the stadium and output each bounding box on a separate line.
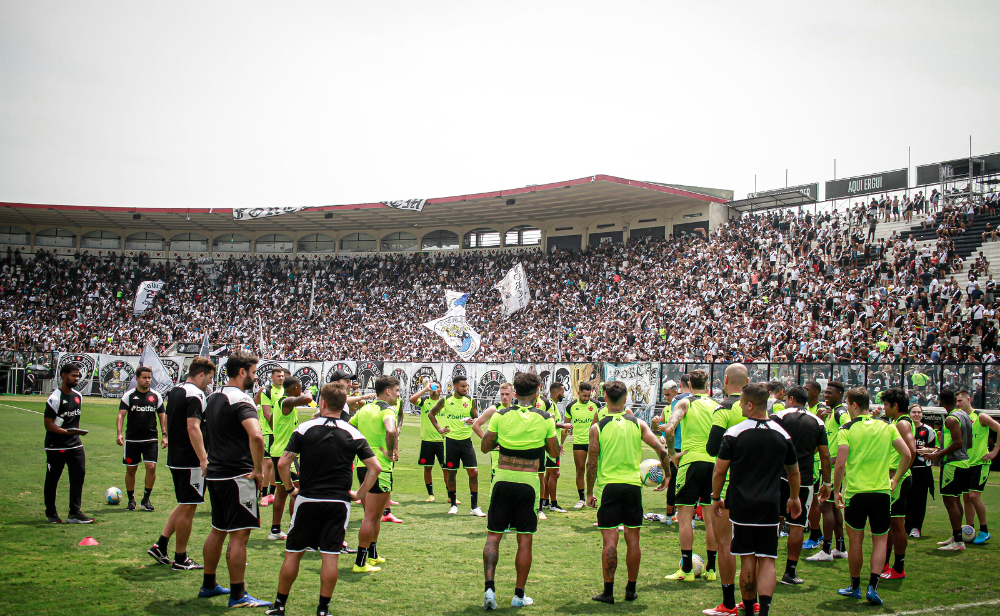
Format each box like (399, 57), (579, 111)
(0, 0), (1000, 208)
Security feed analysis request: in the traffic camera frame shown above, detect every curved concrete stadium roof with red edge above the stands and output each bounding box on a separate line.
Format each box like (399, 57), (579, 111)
(0, 175), (732, 234)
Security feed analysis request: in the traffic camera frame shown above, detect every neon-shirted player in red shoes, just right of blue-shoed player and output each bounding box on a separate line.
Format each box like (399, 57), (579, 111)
(882, 387), (917, 580)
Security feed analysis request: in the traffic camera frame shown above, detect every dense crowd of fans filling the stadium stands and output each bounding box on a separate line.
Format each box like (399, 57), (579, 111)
(0, 188), (1000, 370)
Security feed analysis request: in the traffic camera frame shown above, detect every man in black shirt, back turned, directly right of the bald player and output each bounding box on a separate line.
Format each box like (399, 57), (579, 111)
(708, 378), (802, 616)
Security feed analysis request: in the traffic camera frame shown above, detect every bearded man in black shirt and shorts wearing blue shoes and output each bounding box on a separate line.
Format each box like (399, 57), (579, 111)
(198, 351), (271, 607)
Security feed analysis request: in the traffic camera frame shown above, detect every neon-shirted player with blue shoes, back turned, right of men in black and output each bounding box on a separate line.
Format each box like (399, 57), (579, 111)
(833, 387), (912, 605)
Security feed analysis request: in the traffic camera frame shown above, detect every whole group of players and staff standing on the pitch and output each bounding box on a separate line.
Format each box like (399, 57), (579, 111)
(45, 353), (1000, 616)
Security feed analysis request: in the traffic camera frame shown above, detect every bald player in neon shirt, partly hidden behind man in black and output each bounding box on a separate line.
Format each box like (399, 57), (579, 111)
(702, 364), (749, 616)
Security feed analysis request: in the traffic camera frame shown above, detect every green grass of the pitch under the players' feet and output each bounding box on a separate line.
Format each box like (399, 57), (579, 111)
(0, 396), (1000, 616)
